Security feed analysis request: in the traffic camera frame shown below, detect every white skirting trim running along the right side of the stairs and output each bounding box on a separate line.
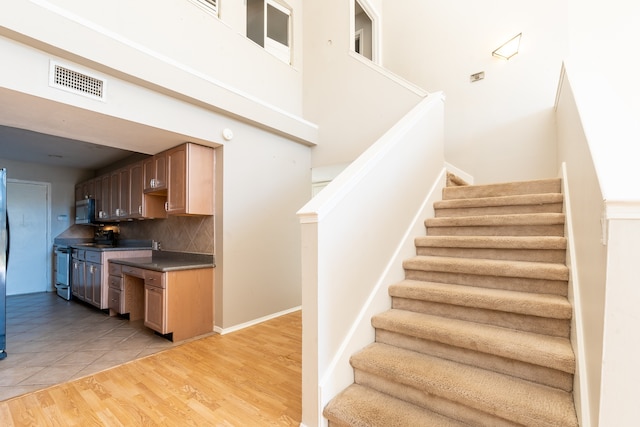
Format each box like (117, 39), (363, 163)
(561, 162), (591, 427)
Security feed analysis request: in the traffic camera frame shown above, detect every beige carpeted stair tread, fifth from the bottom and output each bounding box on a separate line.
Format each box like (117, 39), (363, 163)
(403, 255), (569, 280)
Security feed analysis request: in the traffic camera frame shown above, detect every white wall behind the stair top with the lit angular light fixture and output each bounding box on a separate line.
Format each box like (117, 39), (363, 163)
(382, 0), (568, 184)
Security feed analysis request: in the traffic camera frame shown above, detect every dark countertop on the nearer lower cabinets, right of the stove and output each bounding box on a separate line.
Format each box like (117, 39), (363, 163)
(109, 251), (216, 272)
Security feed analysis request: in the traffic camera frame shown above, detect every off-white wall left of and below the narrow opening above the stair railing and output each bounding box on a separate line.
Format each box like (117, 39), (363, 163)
(303, 0), (426, 167)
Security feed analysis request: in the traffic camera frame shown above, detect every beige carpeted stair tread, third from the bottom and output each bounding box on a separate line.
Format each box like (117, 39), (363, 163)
(371, 309), (575, 374)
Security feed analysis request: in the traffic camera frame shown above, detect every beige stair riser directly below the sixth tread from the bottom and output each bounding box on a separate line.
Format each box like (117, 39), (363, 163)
(416, 246), (566, 264)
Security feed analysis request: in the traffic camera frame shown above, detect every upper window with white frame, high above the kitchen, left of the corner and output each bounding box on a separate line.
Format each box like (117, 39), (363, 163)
(247, 0), (291, 64)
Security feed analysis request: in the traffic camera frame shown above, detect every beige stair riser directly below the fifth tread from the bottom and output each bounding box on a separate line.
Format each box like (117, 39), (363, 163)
(405, 269), (568, 297)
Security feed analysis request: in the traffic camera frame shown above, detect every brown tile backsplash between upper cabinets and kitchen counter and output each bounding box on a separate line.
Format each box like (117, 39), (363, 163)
(119, 216), (215, 254)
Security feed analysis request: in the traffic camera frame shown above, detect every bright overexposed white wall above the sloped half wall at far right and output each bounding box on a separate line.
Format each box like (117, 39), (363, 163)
(569, 0), (640, 200)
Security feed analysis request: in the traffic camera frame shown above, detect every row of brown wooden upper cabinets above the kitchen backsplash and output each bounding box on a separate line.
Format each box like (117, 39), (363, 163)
(75, 142), (215, 222)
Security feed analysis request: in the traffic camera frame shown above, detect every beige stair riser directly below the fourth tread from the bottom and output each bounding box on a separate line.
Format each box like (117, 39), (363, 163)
(392, 297), (571, 338)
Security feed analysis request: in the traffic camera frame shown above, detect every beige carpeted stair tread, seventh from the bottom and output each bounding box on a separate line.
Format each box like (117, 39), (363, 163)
(424, 212), (565, 228)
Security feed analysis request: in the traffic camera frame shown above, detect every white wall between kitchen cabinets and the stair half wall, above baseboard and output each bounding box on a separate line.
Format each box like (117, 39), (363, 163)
(216, 123), (311, 329)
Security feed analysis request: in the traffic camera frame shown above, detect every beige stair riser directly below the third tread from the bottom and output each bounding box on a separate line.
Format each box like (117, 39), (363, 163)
(376, 329), (573, 392)
